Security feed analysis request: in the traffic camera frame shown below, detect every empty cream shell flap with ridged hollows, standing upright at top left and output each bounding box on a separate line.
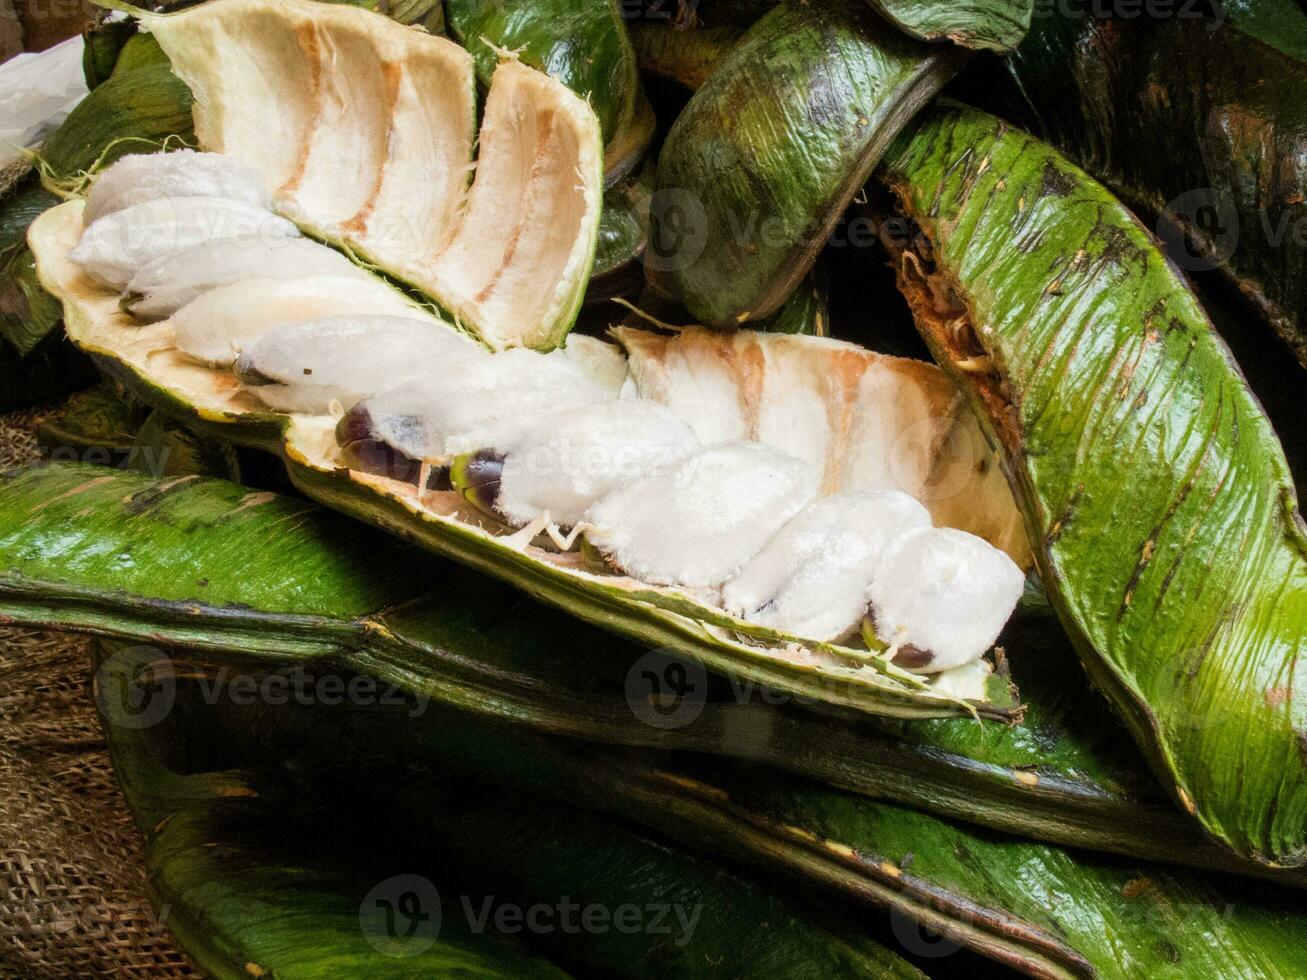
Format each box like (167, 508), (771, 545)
(100, 0), (604, 349)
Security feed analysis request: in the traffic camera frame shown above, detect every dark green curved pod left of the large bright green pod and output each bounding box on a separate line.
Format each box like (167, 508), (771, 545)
(646, 0), (962, 327)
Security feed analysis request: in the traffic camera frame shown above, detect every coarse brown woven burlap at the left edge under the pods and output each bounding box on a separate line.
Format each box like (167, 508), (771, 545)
(0, 413), (200, 980)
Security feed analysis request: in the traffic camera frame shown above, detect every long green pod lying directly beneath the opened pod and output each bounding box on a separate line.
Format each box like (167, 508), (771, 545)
(0, 464), (1307, 882)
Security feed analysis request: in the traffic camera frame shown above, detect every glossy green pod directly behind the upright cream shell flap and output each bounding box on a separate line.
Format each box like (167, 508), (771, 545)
(444, 0), (654, 187)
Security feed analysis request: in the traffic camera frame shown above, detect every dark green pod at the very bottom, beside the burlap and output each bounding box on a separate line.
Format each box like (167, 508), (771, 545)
(95, 647), (923, 980)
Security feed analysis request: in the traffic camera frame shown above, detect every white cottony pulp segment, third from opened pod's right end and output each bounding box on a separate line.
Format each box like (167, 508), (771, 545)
(584, 443), (819, 588)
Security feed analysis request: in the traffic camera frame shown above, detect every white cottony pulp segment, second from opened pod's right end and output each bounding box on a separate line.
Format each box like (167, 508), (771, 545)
(721, 490), (931, 642)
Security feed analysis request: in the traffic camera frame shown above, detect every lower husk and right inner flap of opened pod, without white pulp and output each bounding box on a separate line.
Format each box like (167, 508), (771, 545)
(30, 185), (1029, 717)
